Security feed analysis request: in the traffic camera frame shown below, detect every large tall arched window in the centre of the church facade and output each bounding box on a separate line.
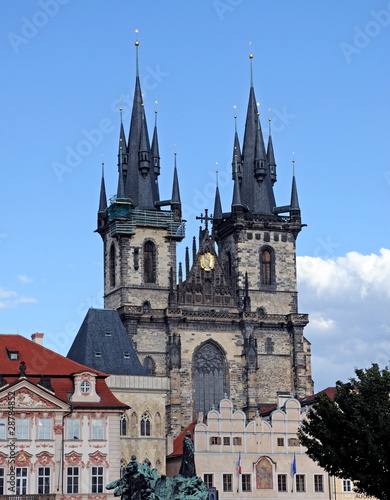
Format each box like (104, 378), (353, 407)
(193, 342), (228, 415)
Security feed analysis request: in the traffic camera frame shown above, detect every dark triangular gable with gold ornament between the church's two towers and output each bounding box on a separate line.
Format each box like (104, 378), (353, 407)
(179, 230), (236, 308)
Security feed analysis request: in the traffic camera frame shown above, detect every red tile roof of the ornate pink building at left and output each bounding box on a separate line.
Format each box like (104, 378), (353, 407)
(0, 335), (127, 410)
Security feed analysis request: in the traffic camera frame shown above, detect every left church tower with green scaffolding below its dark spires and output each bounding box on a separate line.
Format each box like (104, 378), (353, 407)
(97, 41), (185, 376)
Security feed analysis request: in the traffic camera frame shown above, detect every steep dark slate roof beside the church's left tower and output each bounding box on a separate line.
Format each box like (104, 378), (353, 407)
(67, 308), (147, 375)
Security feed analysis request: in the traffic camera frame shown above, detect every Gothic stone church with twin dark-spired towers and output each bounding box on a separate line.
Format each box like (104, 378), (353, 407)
(97, 42), (313, 436)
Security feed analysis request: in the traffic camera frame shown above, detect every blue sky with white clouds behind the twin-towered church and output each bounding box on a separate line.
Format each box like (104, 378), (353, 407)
(0, 0), (390, 390)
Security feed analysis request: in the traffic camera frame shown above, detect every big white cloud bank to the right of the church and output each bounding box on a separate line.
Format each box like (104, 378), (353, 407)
(297, 248), (390, 390)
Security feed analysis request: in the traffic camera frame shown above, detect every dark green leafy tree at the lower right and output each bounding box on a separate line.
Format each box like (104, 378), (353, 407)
(298, 364), (390, 500)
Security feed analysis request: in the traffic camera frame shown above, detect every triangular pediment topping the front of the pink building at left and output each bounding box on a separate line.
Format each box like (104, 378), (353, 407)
(0, 378), (70, 411)
